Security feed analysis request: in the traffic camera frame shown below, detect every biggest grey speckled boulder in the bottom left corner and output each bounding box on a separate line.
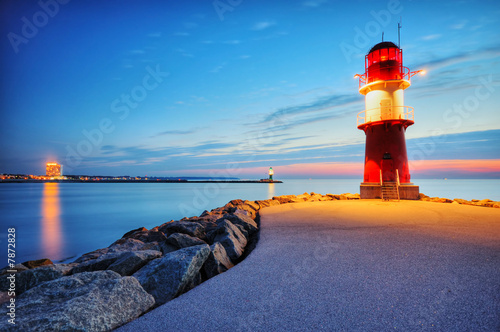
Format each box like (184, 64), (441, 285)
(0, 271), (154, 331)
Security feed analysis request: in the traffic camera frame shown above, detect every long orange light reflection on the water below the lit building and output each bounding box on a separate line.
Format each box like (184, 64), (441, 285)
(41, 183), (62, 259)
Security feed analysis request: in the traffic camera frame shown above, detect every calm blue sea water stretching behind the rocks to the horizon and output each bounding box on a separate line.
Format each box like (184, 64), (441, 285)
(0, 179), (500, 266)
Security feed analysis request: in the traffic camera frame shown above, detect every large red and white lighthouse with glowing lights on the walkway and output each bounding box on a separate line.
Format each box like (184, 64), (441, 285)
(354, 42), (423, 199)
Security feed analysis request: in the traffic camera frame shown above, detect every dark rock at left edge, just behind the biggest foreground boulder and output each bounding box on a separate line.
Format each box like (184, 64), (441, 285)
(0, 265), (64, 295)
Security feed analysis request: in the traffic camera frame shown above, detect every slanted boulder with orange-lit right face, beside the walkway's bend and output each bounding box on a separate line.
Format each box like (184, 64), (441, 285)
(213, 220), (247, 263)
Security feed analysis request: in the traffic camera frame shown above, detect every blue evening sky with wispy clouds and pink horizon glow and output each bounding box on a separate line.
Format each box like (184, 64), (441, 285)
(0, 0), (500, 179)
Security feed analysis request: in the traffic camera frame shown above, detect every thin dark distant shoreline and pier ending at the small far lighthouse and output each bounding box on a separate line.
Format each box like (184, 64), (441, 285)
(0, 179), (283, 183)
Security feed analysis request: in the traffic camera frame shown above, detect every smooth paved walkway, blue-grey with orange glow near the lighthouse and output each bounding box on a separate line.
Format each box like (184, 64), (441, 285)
(119, 200), (500, 332)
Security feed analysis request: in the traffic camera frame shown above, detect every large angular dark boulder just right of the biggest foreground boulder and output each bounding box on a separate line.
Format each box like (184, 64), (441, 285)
(133, 244), (210, 305)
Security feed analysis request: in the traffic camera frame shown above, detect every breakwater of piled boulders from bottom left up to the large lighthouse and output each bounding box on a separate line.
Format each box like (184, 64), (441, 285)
(0, 193), (359, 331)
